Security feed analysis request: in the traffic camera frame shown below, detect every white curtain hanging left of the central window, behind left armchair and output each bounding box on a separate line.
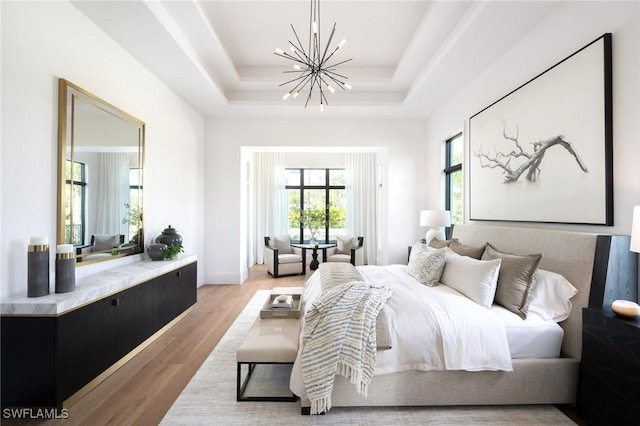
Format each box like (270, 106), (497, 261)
(253, 152), (289, 264)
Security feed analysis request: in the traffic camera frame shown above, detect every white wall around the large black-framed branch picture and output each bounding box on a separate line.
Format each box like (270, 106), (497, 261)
(425, 1), (640, 234)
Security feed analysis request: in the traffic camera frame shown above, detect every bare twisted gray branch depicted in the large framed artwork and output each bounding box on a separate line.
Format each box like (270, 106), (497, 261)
(473, 122), (589, 183)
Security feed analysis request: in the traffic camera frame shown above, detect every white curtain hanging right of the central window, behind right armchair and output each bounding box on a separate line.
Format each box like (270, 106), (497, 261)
(345, 152), (377, 265)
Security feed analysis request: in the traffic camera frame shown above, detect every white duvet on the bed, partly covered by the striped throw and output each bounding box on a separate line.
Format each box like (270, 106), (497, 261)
(291, 265), (519, 396)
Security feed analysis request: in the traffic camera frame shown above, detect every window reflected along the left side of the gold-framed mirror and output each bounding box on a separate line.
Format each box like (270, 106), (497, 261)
(64, 160), (87, 246)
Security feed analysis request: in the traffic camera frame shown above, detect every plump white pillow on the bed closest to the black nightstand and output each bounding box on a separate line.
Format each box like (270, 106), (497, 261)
(529, 269), (578, 322)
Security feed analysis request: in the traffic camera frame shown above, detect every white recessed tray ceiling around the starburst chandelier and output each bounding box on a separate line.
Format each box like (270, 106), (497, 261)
(73, 0), (559, 117)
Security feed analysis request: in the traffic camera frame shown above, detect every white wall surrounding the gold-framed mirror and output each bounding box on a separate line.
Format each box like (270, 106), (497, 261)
(0, 1), (204, 297)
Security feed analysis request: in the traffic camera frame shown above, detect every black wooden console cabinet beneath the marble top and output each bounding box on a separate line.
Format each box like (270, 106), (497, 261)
(0, 262), (197, 407)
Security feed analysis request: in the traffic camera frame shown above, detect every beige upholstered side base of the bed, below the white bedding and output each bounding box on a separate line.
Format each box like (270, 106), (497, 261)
(300, 358), (580, 413)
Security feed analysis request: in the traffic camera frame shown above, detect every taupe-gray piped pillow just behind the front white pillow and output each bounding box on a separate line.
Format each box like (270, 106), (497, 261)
(482, 243), (542, 318)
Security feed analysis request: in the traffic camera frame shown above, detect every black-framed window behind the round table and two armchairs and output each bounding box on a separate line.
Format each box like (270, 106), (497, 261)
(286, 169), (345, 243)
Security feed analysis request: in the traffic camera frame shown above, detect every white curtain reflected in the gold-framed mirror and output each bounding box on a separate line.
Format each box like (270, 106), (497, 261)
(93, 152), (129, 234)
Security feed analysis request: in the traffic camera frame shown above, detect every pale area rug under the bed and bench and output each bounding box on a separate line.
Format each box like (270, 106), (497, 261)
(161, 290), (574, 426)
